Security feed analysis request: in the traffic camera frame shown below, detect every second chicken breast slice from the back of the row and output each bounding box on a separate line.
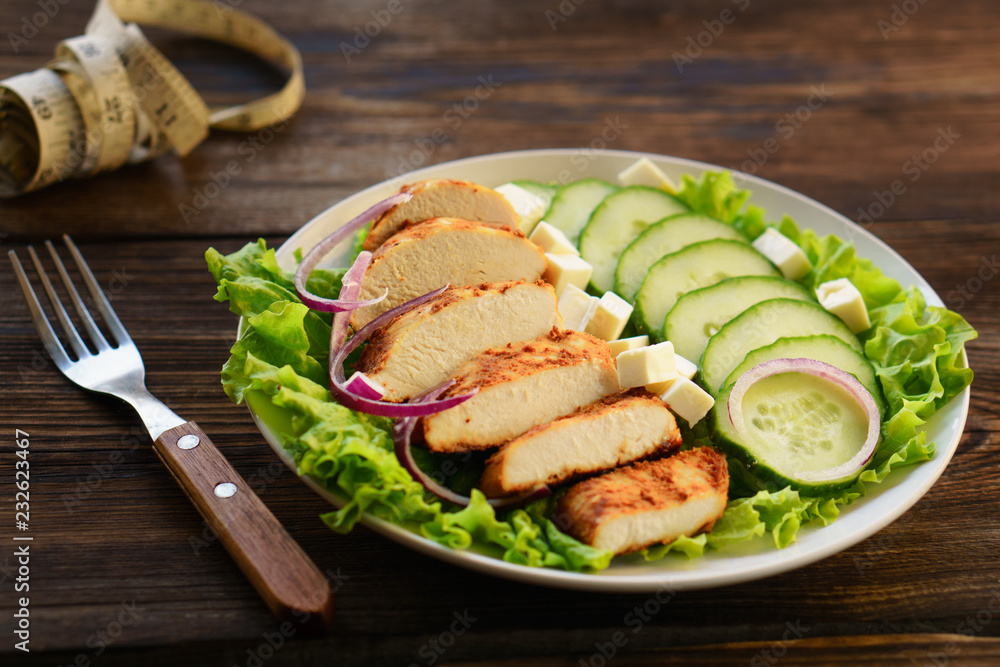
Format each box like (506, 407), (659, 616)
(351, 218), (545, 329)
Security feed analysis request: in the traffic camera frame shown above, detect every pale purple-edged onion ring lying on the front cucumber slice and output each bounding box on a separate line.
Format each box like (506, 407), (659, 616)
(727, 358), (882, 482)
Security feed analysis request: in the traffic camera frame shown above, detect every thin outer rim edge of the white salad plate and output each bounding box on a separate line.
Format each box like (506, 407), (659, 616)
(240, 148), (971, 593)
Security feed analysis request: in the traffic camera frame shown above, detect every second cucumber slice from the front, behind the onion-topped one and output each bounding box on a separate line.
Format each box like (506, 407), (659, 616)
(724, 334), (885, 414)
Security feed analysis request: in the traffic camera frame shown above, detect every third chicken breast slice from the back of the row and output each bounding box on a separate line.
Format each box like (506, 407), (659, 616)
(357, 281), (562, 401)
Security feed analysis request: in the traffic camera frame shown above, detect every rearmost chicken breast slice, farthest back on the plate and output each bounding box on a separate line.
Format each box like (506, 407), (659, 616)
(363, 178), (518, 252)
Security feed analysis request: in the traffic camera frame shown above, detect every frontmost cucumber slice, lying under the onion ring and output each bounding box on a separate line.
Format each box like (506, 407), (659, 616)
(711, 373), (880, 495)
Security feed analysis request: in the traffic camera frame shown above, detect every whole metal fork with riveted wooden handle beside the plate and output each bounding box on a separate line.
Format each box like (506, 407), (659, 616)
(7, 235), (333, 630)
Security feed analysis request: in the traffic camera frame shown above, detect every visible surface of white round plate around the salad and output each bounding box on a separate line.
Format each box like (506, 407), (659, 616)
(242, 149), (969, 592)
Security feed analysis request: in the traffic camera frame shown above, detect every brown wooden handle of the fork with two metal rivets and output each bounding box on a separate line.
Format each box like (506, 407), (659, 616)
(153, 422), (333, 632)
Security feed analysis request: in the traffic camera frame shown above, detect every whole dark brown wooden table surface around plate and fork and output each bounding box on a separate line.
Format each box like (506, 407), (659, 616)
(0, 0), (1000, 667)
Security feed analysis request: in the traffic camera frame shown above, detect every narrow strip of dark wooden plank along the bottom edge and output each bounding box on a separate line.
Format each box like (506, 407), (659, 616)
(9, 636), (1000, 667)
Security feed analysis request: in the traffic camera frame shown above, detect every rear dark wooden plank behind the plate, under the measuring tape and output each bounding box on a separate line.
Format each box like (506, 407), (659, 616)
(0, 0), (1000, 237)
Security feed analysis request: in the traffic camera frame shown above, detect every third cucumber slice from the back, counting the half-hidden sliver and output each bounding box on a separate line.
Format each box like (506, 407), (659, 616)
(580, 185), (688, 293)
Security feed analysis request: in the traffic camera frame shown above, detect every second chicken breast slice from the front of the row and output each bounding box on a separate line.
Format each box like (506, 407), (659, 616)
(480, 388), (681, 498)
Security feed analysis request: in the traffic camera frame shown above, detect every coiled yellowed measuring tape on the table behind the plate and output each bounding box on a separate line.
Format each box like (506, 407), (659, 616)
(0, 0), (305, 197)
